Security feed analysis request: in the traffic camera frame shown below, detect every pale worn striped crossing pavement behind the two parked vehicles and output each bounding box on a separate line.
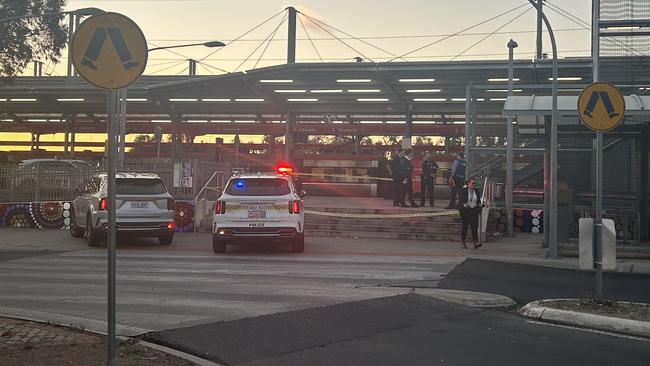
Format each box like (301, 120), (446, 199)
(0, 230), (464, 335)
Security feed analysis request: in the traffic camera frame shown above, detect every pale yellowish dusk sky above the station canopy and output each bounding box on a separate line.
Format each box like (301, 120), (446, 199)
(26, 0), (591, 75)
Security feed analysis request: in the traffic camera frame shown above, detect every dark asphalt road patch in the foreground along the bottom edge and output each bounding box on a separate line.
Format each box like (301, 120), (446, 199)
(145, 295), (650, 366)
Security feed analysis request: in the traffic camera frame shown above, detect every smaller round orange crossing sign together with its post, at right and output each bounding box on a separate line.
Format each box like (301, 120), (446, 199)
(578, 82), (625, 302)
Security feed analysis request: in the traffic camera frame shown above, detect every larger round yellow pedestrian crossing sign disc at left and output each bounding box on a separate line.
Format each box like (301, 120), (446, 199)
(71, 13), (147, 89)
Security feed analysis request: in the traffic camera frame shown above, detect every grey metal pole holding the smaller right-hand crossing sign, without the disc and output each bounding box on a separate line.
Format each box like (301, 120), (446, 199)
(591, 0), (603, 303)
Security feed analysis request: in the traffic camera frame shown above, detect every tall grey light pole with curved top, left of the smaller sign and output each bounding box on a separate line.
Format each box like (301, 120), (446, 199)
(528, 0), (558, 258)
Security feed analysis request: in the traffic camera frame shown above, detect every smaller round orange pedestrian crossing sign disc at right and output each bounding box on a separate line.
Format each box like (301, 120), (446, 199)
(578, 82), (625, 132)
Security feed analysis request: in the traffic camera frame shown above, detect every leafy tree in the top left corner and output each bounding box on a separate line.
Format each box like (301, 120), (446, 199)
(0, 0), (68, 77)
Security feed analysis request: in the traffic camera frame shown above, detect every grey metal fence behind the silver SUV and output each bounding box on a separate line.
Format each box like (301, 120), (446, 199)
(0, 159), (230, 203)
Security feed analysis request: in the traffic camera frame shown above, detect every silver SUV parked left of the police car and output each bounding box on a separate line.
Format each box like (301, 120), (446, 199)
(70, 173), (175, 246)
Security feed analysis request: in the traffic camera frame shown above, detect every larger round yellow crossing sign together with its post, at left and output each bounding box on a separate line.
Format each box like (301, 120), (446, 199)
(71, 13), (147, 366)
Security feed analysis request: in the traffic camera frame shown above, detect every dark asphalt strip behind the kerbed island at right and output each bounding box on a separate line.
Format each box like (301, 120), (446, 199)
(438, 259), (650, 304)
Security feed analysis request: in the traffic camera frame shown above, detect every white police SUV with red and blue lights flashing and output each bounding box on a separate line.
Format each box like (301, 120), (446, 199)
(212, 166), (305, 253)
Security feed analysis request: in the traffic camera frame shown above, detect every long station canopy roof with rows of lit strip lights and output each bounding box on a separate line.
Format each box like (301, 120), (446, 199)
(0, 57), (650, 136)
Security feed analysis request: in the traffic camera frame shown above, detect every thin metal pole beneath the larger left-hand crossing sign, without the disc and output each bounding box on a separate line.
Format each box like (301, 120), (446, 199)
(106, 89), (118, 366)
